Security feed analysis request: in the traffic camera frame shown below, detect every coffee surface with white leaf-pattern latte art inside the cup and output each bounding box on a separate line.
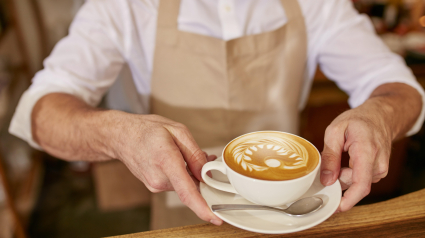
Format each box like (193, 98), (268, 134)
(223, 131), (320, 181)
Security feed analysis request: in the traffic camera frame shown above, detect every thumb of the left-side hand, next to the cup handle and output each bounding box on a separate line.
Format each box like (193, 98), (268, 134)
(164, 124), (207, 181)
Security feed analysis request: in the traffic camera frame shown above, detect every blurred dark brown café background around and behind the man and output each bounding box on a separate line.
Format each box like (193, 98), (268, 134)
(0, 0), (425, 238)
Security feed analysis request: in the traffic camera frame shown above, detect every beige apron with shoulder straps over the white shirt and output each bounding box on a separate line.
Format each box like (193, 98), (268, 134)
(151, 0), (307, 151)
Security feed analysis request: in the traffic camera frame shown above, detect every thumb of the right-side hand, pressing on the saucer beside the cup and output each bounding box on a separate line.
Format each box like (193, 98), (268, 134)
(320, 124), (345, 186)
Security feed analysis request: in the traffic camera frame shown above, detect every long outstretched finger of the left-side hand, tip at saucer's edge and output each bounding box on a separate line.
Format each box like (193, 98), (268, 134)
(163, 151), (222, 225)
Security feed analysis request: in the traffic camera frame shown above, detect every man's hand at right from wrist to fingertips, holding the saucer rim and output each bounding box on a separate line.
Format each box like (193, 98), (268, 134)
(321, 102), (393, 211)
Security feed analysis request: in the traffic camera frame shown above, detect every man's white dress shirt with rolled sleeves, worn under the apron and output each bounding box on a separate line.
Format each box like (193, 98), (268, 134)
(9, 0), (425, 148)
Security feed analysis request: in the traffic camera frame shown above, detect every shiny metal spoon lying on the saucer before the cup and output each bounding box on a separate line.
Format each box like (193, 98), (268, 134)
(211, 197), (323, 216)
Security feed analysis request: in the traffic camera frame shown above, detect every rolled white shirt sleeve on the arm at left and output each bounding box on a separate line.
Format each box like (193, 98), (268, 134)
(9, 1), (124, 149)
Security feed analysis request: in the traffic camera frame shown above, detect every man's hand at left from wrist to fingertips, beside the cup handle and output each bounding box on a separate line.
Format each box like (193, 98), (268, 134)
(112, 112), (222, 225)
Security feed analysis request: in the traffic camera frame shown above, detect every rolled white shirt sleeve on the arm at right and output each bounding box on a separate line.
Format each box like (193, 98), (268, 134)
(317, 0), (425, 136)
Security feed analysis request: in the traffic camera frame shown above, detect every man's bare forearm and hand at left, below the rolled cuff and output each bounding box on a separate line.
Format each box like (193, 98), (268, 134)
(32, 93), (222, 225)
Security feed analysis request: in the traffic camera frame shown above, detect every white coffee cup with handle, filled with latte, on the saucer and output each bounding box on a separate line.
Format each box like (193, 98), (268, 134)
(202, 131), (321, 207)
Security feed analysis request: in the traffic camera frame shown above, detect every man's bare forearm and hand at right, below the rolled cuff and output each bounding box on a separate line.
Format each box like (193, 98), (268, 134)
(321, 83), (422, 211)
